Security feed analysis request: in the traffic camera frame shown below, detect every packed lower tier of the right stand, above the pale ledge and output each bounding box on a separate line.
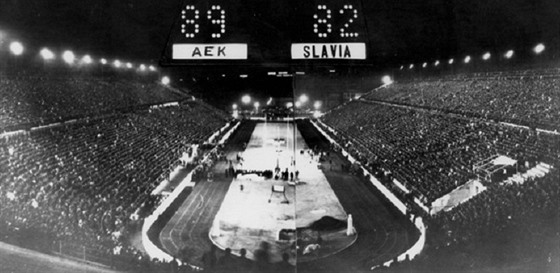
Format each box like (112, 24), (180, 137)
(322, 101), (560, 204)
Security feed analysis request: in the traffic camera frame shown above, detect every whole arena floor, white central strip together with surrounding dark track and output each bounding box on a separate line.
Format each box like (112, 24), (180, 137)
(159, 121), (417, 272)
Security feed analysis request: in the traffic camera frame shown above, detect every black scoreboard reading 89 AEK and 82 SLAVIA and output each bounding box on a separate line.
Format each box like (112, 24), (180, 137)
(162, 0), (368, 64)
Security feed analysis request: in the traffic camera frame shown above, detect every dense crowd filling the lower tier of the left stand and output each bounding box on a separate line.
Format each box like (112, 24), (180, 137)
(0, 101), (226, 268)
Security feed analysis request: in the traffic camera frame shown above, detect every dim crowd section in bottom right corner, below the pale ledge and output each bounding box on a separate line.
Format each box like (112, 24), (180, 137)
(381, 168), (560, 272)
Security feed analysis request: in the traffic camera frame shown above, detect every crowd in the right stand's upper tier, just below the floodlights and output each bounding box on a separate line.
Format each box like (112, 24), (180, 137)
(363, 68), (560, 130)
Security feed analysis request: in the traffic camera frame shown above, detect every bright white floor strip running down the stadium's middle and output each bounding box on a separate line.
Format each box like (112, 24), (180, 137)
(210, 123), (347, 261)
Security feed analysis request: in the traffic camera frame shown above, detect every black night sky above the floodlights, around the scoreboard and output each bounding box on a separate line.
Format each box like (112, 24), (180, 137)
(0, 0), (560, 104)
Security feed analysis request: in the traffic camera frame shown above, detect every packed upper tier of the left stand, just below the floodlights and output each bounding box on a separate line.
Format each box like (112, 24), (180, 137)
(0, 76), (185, 132)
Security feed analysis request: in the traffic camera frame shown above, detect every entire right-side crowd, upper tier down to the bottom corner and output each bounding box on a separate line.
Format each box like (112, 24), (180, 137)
(322, 69), (560, 272)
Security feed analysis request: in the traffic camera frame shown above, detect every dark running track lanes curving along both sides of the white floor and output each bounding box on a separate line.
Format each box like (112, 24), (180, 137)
(160, 122), (418, 272)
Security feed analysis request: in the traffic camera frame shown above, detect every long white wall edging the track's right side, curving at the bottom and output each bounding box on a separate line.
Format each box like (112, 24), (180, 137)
(311, 120), (426, 270)
